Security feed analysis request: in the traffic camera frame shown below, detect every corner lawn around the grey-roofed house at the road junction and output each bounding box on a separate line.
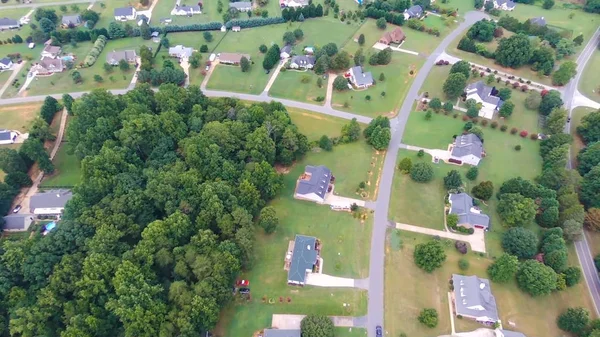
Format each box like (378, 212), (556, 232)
(331, 50), (424, 117)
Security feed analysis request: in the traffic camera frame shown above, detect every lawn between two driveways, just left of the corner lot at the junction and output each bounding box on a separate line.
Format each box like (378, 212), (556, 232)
(269, 70), (327, 105)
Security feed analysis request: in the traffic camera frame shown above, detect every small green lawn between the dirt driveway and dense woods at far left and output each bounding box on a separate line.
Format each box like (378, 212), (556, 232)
(41, 143), (81, 187)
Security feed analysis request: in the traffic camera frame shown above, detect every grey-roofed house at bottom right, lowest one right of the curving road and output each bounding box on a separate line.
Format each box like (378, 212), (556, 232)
(452, 274), (498, 324)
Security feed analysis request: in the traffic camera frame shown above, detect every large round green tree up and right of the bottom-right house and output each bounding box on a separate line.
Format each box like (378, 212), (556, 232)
(517, 260), (558, 297)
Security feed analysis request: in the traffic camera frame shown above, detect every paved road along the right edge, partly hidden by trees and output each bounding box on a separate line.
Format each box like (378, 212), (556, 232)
(563, 28), (600, 316)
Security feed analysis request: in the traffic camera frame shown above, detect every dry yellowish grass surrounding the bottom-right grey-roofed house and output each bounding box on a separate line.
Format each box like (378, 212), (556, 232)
(384, 231), (593, 336)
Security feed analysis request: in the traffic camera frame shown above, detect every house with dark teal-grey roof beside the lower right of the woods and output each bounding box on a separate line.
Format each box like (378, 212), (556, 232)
(285, 235), (319, 286)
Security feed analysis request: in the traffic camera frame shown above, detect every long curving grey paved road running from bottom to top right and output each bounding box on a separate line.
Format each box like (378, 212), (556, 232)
(367, 12), (487, 337)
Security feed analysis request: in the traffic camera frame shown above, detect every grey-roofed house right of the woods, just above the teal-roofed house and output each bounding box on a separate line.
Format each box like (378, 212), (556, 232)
(294, 165), (335, 203)
